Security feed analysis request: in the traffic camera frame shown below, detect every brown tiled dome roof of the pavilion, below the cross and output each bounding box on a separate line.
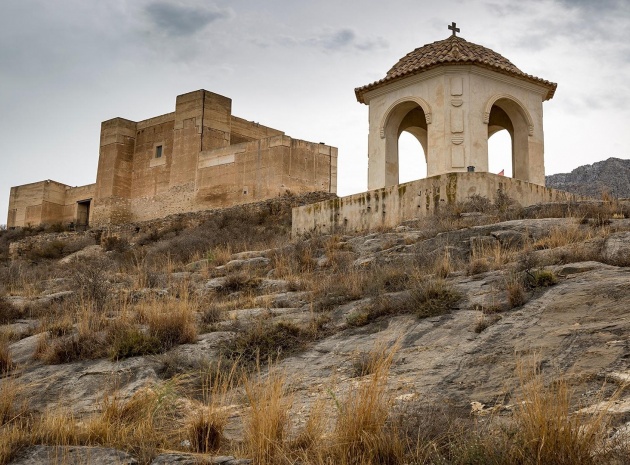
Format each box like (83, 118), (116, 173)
(355, 35), (557, 103)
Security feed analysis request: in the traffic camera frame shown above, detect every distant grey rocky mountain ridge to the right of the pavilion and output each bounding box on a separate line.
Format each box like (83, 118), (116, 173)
(545, 157), (630, 199)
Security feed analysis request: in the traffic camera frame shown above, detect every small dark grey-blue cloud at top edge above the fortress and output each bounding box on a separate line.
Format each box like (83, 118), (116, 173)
(145, 2), (231, 37)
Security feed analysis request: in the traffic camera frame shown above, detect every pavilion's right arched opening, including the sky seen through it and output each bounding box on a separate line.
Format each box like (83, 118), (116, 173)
(488, 97), (531, 181)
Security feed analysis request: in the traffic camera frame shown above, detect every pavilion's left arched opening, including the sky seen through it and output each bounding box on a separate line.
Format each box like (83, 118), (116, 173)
(383, 101), (428, 186)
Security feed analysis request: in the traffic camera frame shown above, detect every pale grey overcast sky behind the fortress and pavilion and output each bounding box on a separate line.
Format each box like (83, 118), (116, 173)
(0, 0), (630, 224)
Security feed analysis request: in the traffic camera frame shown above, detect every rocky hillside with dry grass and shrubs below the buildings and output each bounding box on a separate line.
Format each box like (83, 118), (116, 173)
(0, 198), (630, 465)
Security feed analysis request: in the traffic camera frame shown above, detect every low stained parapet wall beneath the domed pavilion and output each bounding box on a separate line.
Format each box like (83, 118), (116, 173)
(292, 172), (584, 237)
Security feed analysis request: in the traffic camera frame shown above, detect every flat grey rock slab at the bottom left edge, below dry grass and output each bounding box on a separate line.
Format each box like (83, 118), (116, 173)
(10, 446), (138, 465)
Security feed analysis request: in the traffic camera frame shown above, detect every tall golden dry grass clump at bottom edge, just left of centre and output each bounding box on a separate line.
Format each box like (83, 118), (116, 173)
(244, 367), (292, 465)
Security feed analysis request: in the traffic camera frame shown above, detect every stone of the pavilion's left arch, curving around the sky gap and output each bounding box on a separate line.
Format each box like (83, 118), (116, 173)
(380, 97), (431, 185)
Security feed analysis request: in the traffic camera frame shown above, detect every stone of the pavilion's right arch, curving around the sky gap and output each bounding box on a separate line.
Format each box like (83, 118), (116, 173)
(483, 94), (534, 181)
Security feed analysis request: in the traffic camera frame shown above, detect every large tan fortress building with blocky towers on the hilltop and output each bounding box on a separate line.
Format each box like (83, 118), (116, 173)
(7, 90), (337, 227)
